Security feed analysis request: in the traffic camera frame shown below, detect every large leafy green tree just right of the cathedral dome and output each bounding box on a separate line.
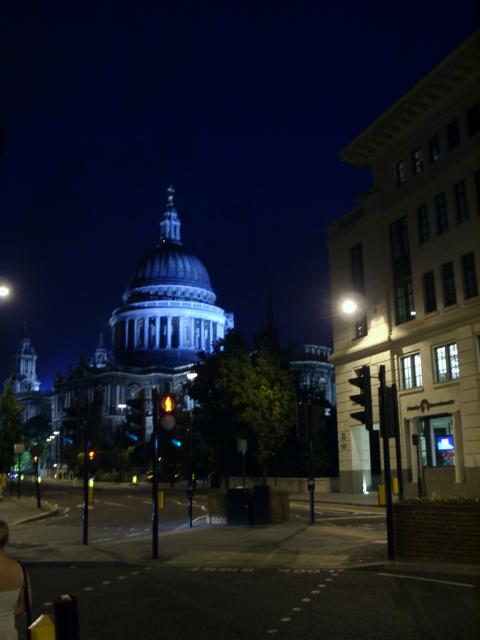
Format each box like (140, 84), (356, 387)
(190, 331), (296, 478)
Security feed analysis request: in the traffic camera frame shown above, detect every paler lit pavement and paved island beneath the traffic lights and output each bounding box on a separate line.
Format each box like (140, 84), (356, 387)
(0, 487), (480, 575)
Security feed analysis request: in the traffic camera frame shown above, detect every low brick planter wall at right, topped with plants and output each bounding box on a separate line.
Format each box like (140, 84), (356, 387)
(393, 503), (480, 564)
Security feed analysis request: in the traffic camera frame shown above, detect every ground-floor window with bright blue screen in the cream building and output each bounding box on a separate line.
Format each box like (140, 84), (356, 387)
(418, 415), (455, 467)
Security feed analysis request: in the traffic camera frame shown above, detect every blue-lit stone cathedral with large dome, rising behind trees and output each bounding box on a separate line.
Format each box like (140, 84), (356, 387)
(12, 187), (234, 441)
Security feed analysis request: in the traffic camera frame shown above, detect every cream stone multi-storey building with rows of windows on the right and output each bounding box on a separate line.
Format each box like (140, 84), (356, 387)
(328, 31), (480, 495)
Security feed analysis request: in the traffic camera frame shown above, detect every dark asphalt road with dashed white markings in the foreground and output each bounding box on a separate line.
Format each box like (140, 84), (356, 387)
(19, 563), (480, 640)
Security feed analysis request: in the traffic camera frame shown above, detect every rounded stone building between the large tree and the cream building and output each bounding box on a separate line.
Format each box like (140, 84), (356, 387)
(290, 344), (335, 405)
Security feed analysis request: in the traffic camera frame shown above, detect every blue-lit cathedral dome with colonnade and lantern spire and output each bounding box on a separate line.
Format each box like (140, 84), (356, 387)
(110, 187), (233, 370)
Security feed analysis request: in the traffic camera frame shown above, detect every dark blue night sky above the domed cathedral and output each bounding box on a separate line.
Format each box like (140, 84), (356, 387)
(0, 0), (479, 390)
